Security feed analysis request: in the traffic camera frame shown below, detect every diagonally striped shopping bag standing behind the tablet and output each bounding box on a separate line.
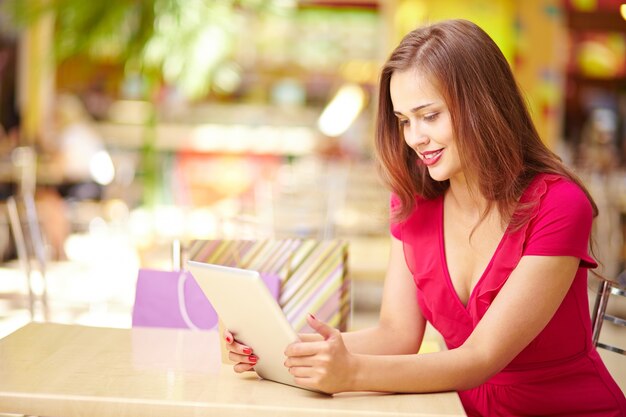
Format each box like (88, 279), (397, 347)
(187, 239), (352, 332)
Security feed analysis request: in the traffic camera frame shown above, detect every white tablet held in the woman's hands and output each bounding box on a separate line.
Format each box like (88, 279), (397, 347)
(187, 261), (312, 388)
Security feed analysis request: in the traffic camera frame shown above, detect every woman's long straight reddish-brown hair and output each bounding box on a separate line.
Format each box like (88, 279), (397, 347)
(376, 20), (597, 230)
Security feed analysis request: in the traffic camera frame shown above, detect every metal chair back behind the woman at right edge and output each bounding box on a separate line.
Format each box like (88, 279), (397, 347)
(591, 270), (626, 355)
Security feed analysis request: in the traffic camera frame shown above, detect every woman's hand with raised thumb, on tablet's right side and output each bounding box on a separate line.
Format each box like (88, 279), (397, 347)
(285, 314), (357, 394)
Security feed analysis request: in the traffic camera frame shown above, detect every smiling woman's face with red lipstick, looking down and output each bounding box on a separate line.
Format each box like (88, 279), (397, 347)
(389, 70), (463, 181)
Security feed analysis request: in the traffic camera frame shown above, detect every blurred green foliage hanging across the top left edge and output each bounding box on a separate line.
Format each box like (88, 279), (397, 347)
(3, 0), (290, 98)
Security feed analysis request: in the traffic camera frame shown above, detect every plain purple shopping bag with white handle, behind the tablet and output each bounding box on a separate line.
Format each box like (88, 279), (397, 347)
(132, 269), (280, 330)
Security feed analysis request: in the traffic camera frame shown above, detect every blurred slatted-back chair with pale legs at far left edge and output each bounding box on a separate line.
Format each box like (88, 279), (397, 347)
(7, 193), (49, 320)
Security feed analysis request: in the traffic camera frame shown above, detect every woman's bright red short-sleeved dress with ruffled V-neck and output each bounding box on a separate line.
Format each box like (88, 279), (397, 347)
(391, 175), (626, 417)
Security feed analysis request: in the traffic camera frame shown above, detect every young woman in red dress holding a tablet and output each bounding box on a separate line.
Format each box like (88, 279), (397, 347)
(225, 20), (626, 416)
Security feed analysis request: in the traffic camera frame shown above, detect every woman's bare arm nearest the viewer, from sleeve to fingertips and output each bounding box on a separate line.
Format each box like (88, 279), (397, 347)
(285, 256), (580, 393)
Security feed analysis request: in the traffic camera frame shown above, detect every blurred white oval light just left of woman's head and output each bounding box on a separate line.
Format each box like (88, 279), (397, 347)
(317, 84), (365, 137)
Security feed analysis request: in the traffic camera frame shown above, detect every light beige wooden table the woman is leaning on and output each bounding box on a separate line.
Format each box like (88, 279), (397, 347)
(0, 323), (465, 417)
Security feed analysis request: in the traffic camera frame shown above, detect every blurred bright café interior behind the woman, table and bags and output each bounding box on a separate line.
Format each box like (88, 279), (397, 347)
(0, 0), (626, 380)
